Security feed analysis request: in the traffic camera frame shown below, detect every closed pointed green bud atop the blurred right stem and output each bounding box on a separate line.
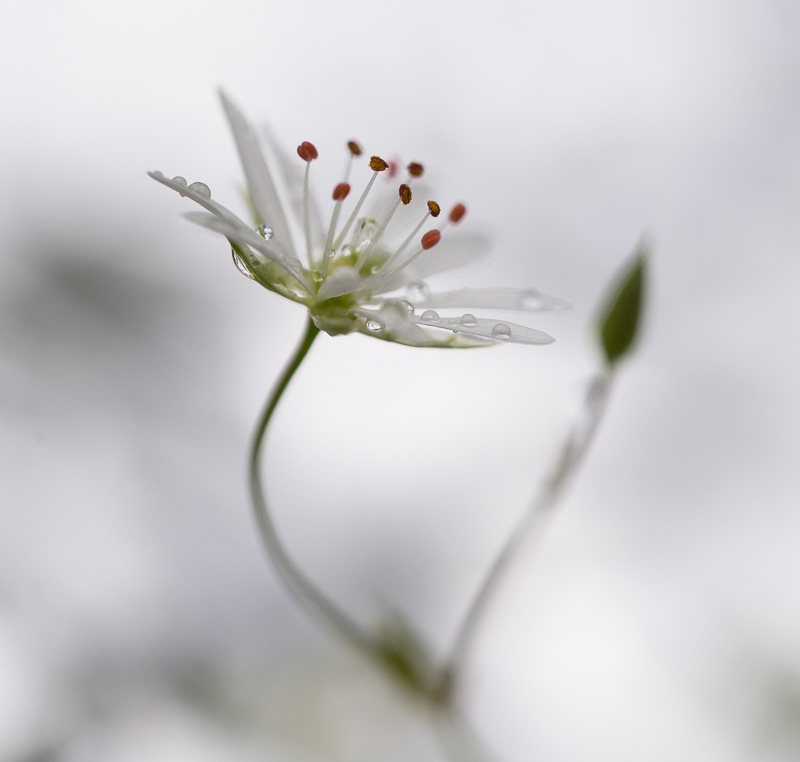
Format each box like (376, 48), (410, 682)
(597, 243), (648, 368)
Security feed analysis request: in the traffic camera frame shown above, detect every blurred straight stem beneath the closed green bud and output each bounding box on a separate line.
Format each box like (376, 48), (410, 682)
(440, 373), (611, 692)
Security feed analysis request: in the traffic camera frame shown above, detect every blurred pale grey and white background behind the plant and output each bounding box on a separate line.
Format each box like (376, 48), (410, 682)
(0, 0), (800, 762)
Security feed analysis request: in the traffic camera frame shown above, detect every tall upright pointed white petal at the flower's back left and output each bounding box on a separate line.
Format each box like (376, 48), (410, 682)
(220, 92), (295, 256)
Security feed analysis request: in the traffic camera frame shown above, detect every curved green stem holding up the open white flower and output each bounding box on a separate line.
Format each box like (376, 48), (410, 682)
(249, 317), (377, 657)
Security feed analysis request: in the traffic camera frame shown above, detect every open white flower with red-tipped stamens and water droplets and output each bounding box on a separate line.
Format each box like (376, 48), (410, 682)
(149, 95), (567, 347)
